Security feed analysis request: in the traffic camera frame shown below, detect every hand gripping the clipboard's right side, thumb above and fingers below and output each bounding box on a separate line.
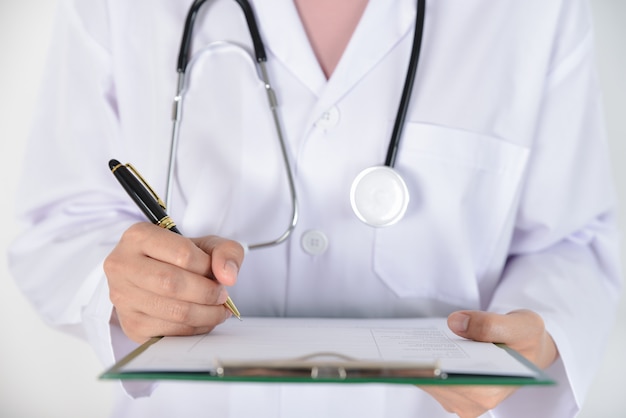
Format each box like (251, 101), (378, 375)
(421, 310), (558, 418)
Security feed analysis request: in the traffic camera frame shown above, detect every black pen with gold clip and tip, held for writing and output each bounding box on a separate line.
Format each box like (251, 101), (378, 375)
(109, 160), (241, 320)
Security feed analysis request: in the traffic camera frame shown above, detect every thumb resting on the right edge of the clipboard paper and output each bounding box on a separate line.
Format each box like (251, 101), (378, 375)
(448, 310), (545, 347)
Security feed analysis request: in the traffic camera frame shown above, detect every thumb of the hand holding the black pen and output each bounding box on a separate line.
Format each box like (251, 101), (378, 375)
(193, 236), (244, 286)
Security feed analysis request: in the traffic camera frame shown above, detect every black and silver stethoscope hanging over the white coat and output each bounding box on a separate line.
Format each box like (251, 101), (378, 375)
(165, 0), (426, 249)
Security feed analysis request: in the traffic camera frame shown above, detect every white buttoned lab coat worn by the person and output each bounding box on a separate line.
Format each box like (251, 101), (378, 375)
(10, 0), (620, 417)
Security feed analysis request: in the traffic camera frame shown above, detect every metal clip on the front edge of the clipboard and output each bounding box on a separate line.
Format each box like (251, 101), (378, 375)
(215, 352), (447, 381)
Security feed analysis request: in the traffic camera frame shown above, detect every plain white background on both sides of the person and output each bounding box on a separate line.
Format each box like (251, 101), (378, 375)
(0, 0), (626, 418)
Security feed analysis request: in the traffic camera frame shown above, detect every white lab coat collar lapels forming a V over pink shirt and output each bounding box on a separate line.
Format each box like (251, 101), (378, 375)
(255, 0), (416, 109)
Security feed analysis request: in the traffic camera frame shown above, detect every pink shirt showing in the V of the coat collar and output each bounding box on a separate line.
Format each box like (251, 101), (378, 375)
(294, 0), (367, 78)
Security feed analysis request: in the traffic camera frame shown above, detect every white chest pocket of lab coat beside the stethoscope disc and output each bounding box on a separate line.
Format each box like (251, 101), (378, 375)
(373, 123), (529, 305)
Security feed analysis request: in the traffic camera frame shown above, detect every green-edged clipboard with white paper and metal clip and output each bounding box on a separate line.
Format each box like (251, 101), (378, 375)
(100, 318), (554, 386)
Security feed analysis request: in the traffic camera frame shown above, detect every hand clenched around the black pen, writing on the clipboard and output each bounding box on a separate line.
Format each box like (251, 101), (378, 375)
(104, 222), (244, 343)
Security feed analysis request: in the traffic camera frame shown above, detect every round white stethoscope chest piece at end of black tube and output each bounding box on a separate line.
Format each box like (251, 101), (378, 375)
(350, 166), (409, 227)
